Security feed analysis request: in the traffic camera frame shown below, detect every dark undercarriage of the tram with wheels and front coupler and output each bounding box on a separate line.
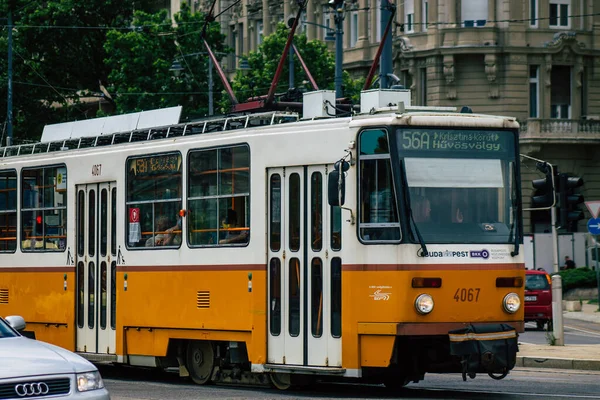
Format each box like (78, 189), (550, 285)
(119, 324), (518, 390)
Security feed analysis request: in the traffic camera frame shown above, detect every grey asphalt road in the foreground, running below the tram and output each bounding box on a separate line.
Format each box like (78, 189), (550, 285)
(101, 366), (600, 400)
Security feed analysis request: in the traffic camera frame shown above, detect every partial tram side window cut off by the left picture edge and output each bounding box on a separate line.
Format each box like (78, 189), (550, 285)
(0, 171), (17, 252)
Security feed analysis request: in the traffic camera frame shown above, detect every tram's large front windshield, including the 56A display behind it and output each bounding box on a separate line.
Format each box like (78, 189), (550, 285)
(396, 128), (518, 244)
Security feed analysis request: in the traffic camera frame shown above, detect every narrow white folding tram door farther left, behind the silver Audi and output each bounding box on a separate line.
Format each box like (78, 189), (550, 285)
(75, 182), (117, 354)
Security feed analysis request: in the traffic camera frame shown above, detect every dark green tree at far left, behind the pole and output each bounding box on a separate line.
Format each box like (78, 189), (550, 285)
(0, 0), (134, 143)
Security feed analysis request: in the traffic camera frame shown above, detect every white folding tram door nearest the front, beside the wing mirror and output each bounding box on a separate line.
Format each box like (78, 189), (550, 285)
(267, 165), (341, 367)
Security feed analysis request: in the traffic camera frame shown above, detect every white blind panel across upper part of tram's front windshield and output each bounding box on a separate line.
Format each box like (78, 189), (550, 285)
(404, 158), (504, 188)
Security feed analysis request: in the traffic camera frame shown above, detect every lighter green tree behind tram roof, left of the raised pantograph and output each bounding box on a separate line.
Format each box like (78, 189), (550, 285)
(104, 4), (227, 116)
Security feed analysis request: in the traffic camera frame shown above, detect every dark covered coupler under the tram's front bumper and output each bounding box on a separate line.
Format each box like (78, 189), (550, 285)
(448, 324), (519, 381)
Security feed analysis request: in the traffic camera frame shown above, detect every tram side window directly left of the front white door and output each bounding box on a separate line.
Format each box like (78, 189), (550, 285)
(188, 145), (250, 246)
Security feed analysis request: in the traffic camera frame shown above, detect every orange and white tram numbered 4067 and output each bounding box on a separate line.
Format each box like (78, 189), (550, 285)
(0, 90), (525, 388)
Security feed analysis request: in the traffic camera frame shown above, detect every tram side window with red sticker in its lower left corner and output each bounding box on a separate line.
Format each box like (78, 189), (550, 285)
(125, 153), (183, 249)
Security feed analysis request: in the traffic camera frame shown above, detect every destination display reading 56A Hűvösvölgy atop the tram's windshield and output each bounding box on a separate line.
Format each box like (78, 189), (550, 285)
(398, 129), (512, 153)
